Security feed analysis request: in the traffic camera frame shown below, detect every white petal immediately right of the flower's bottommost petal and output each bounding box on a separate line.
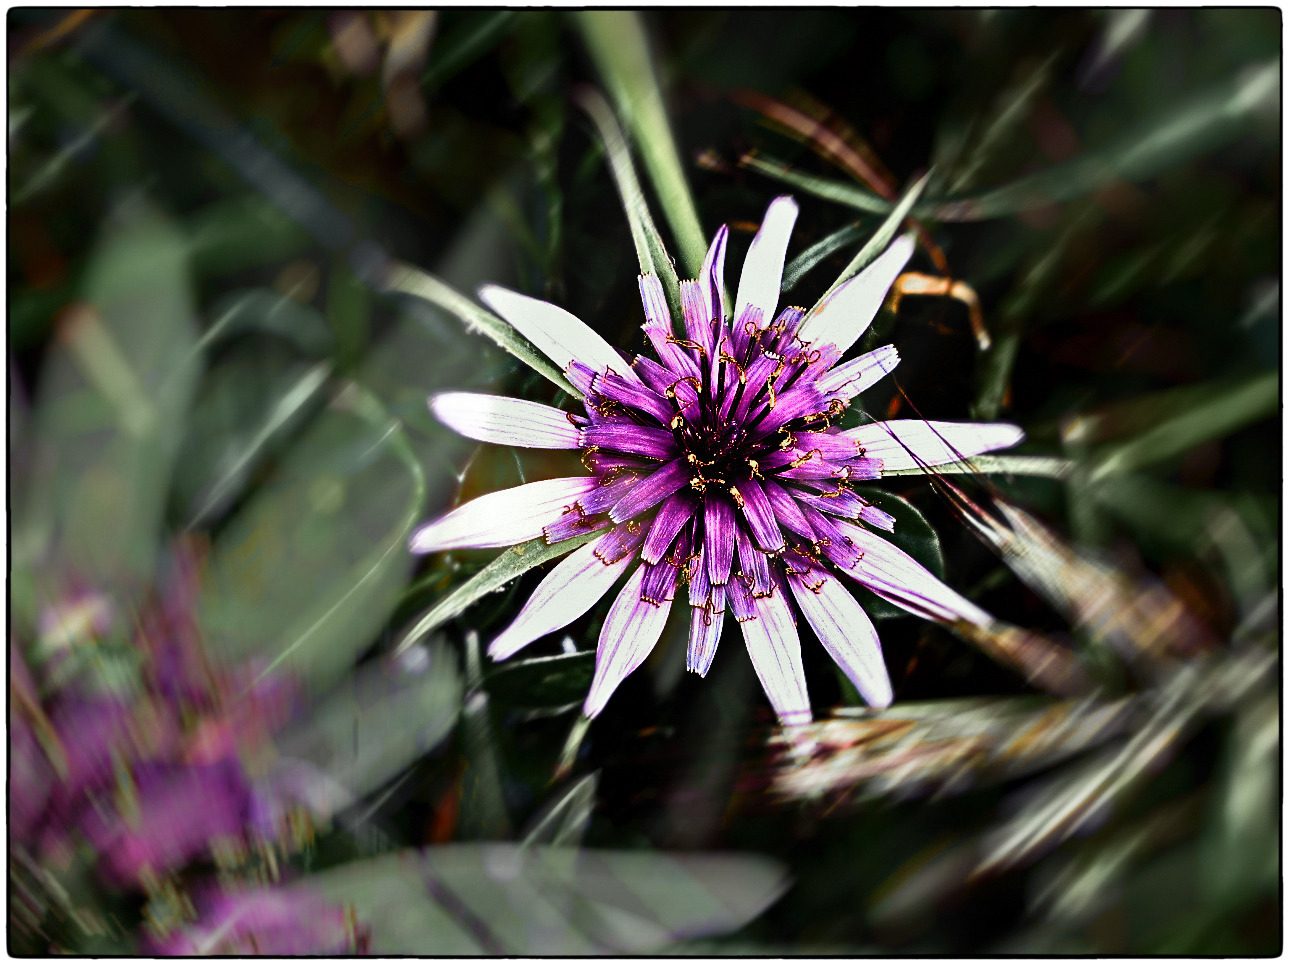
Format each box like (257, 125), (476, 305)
(788, 573), (893, 707)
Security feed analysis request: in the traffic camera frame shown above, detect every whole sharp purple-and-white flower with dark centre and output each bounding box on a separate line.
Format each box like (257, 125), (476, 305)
(410, 197), (1023, 725)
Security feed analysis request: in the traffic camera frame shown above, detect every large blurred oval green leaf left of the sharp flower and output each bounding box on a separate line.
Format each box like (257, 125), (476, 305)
(200, 383), (425, 687)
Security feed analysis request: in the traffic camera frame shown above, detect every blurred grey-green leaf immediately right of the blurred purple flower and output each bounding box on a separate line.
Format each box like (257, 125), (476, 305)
(266, 644), (461, 821)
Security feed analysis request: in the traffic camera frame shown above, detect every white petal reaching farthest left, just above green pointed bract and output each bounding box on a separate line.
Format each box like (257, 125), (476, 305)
(407, 475), (596, 553)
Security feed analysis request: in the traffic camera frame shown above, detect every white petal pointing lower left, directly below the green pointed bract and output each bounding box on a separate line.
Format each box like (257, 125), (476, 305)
(487, 536), (635, 660)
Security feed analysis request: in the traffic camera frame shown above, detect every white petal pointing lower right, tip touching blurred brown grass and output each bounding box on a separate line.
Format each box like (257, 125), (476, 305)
(837, 521), (994, 626)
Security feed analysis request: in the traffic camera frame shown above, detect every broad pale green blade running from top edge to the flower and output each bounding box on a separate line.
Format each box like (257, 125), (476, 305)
(575, 10), (708, 278)
